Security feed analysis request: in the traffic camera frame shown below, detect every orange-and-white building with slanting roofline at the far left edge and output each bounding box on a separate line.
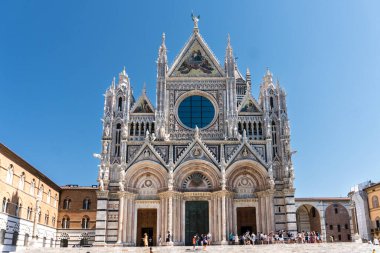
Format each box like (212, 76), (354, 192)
(0, 144), (60, 251)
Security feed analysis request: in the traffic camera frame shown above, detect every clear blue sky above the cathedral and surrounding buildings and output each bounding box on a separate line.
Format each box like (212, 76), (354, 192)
(0, 0), (380, 197)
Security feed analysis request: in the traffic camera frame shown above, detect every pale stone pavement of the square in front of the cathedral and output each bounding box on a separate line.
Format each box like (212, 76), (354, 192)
(11, 243), (380, 253)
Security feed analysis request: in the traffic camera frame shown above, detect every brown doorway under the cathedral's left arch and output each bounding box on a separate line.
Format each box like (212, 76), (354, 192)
(136, 209), (157, 246)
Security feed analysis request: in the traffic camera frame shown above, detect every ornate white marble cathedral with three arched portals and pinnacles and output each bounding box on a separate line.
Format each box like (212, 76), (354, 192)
(95, 18), (297, 246)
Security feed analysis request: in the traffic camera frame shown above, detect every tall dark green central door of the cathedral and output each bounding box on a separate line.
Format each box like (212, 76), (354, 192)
(185, 201), (209, 245)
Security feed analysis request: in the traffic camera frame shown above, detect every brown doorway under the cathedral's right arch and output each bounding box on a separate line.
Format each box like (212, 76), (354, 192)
(236, 207), (257, 235)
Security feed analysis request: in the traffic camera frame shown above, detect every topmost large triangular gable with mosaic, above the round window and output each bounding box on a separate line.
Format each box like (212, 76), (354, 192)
(169, 33), (224, 77)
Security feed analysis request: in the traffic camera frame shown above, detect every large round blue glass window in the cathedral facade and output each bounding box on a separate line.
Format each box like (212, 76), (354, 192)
(178, 96), (215, 129)
